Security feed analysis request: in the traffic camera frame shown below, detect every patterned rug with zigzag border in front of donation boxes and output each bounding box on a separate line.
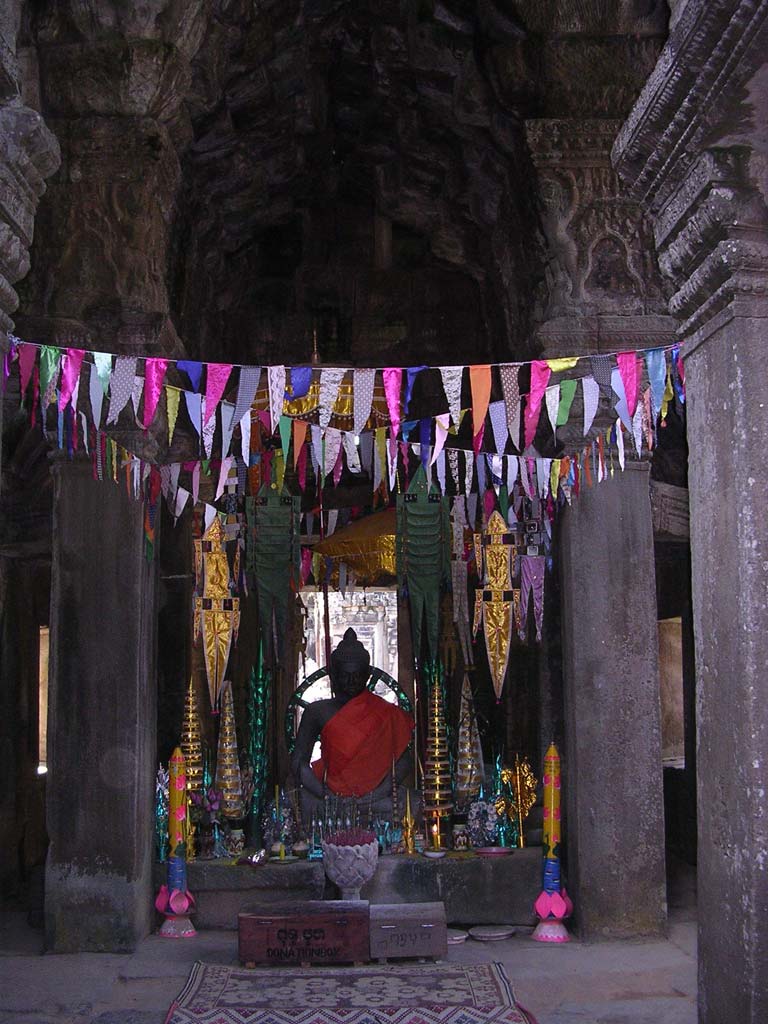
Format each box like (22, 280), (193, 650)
(166, 963), (536, 1024)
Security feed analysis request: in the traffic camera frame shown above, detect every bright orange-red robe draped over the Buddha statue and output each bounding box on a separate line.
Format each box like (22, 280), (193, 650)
(312, 690), (414, 797)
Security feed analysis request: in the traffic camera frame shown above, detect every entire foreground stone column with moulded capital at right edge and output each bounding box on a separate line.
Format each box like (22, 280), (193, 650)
(613, 0), (768, 1024)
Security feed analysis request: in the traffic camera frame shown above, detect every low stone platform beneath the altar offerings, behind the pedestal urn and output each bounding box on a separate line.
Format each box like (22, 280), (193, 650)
(155, 847), (542, 929)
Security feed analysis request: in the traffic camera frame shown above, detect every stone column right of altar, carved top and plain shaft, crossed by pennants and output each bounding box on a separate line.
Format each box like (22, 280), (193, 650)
(525, 119), (674, 938)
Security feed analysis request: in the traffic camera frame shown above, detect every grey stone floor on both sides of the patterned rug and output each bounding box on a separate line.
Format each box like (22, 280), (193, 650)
(0, 907), (696, 1024)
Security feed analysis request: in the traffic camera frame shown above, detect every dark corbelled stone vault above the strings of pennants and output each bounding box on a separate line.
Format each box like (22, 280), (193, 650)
(15, 0), (668, 365)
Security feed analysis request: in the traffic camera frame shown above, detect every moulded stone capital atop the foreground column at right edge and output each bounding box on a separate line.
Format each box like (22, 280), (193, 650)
(612, 0), (768, 338)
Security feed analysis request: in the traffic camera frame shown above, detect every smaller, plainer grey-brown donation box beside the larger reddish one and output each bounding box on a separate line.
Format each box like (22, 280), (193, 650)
(370, 903), (447, 959)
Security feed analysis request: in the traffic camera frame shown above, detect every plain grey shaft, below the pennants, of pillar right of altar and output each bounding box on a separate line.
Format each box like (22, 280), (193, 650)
(558, 463), (667, 939)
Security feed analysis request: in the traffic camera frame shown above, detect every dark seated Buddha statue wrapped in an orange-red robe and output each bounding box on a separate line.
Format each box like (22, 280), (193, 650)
(291, 629), (414, 815)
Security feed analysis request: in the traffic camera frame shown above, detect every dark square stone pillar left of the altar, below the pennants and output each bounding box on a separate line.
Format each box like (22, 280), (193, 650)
(45, 458), (157, 952)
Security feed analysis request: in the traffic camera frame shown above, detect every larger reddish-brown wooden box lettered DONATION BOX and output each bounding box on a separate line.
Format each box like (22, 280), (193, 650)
(238, 900), (370, 966)
